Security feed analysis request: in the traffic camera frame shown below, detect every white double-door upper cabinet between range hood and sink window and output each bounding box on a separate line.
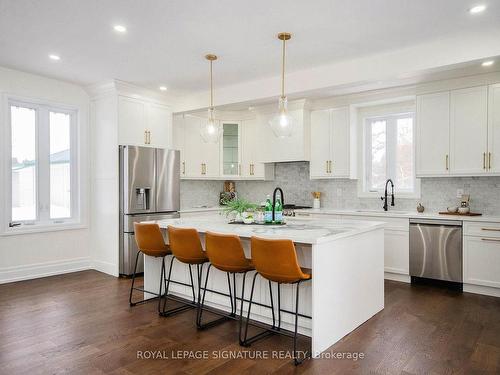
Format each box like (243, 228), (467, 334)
(310, 107), (350, 178)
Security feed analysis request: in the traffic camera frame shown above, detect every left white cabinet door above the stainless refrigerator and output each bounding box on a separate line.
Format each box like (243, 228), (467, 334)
(118, 96), (147, 146)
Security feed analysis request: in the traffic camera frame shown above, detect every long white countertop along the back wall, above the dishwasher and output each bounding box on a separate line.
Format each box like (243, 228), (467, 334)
(295, 208), (500, 222)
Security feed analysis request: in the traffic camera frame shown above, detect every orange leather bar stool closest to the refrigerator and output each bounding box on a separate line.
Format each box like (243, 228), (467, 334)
(129, 223), (172, 310)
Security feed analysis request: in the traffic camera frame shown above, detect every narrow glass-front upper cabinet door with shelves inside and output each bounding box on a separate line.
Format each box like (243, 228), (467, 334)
(220, 121), (241, 177)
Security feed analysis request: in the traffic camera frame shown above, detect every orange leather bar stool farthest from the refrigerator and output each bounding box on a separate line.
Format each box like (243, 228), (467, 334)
(240, 237), (311, 365)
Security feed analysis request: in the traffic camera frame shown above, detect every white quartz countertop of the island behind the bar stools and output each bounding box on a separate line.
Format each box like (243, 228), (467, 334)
(150, 215), (385, 245)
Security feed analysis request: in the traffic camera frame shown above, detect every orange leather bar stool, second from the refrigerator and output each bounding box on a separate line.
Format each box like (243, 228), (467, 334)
(160, 226), (208, 316)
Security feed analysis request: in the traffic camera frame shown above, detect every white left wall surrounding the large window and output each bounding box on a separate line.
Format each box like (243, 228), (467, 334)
(0, 67), (91, 283)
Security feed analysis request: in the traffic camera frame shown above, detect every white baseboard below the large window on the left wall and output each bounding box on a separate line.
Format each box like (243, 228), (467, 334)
(0, 258), (91, 284)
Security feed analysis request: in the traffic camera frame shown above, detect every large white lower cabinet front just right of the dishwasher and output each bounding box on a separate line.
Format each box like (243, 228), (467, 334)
(463, 236), (500, 288)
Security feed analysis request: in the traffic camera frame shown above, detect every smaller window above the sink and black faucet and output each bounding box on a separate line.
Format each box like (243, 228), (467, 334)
(364, 112), (418, 195)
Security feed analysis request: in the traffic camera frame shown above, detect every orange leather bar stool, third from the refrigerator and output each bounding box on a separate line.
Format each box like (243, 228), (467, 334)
(196, 232), (254, 332)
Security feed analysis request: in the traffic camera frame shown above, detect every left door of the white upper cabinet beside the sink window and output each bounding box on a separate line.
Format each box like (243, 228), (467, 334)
(309, 109), (332, 178)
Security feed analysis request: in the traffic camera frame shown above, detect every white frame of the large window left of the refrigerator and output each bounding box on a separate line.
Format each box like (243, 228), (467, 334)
(1, 95), (82, 235)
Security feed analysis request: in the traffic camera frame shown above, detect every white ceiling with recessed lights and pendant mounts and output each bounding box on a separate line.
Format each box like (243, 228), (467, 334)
(0, 0), (500, 91)
